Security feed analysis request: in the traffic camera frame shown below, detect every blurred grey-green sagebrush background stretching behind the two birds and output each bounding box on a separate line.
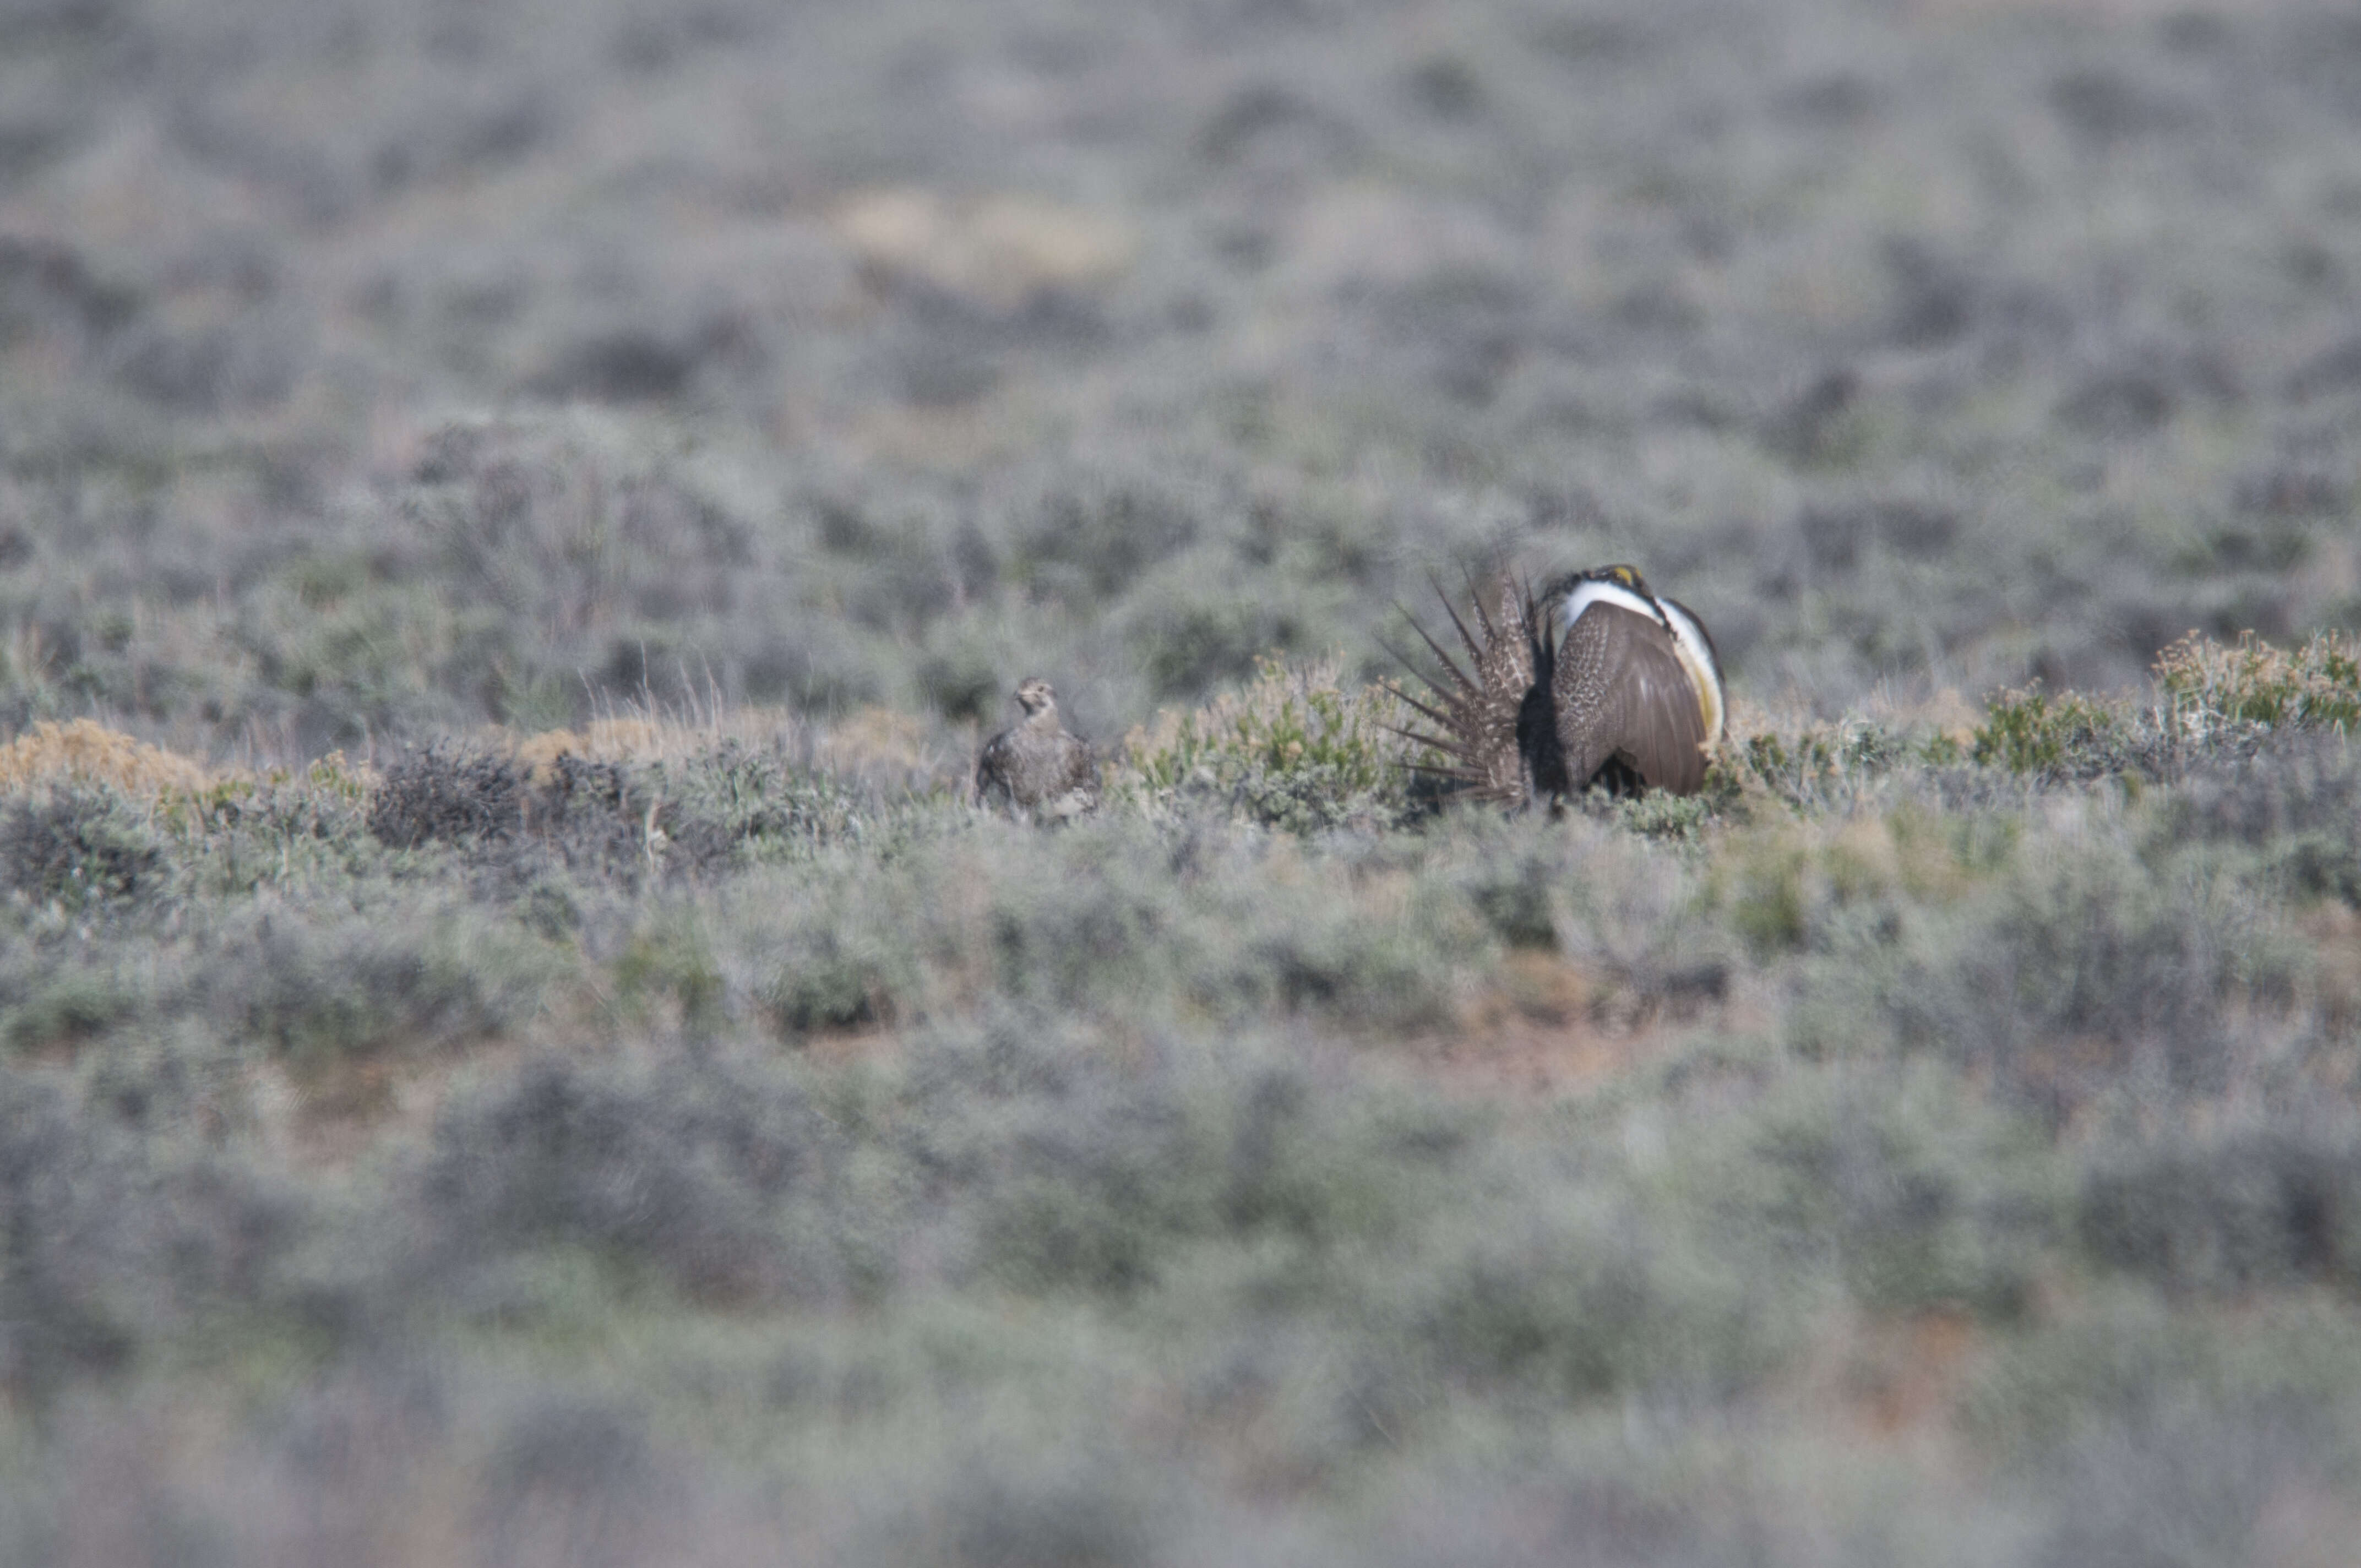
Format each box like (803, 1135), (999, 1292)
(0, 0), (2361, 760)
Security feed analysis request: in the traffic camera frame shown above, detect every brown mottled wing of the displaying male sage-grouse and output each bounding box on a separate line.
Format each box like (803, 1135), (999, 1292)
(1554, 605), (1707, 796)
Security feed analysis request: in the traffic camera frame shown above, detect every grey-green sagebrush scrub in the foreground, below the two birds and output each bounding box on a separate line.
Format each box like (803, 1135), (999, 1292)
(0, 647), (2354, 1561)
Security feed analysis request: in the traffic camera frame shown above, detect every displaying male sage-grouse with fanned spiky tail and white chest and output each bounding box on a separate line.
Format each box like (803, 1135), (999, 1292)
(1402, 567), (1728, 805)
